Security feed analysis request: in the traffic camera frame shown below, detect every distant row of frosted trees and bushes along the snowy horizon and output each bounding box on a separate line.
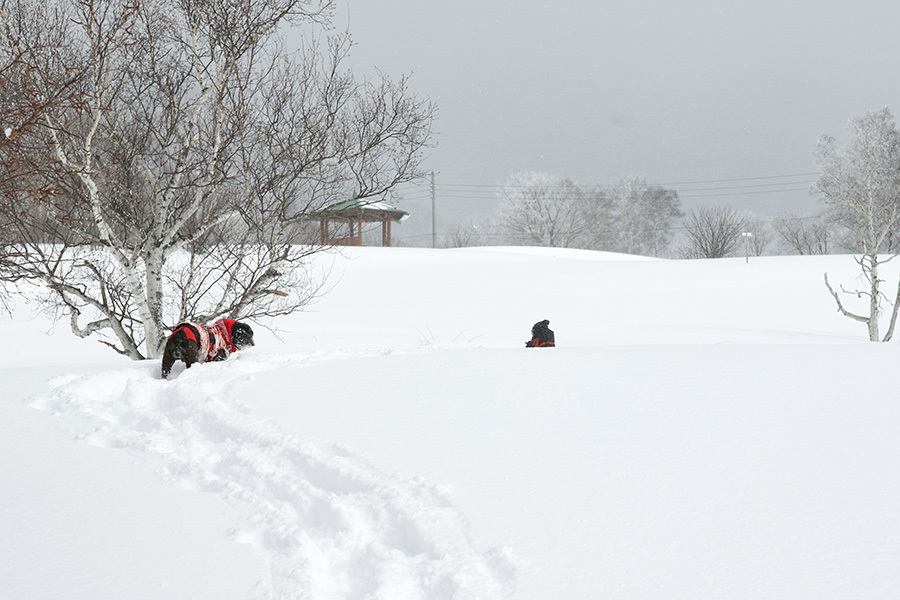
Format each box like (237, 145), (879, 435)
(446, 172), (812, 258)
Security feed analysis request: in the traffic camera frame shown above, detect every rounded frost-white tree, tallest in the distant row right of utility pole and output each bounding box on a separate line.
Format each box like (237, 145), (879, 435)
(499, 172), (587, 248)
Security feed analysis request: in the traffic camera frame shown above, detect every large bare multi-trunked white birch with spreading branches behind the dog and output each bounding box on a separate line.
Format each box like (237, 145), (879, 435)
(0, 0), (433, 359)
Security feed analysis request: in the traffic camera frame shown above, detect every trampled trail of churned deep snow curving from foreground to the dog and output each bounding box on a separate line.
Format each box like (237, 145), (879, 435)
(32, 353), (516, 600)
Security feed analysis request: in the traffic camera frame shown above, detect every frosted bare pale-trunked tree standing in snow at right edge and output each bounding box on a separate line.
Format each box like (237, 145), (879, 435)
(814, 108), (900, 342)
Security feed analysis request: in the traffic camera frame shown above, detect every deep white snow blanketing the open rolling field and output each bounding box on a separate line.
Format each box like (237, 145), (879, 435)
(0, 248), (900, 600)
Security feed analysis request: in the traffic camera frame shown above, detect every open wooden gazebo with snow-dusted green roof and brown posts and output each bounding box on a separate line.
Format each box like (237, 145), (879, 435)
(309, 198), (409, 246)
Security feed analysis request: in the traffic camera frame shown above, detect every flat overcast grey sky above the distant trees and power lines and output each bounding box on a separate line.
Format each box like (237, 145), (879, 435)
(335, 0), (900, 238)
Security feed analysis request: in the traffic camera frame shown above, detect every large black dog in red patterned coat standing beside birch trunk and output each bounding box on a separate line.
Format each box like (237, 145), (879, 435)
(162, 319), (255, 379)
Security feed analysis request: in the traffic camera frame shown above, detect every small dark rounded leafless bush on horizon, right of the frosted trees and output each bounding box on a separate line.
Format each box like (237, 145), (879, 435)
(682, 206), (747, 258)
